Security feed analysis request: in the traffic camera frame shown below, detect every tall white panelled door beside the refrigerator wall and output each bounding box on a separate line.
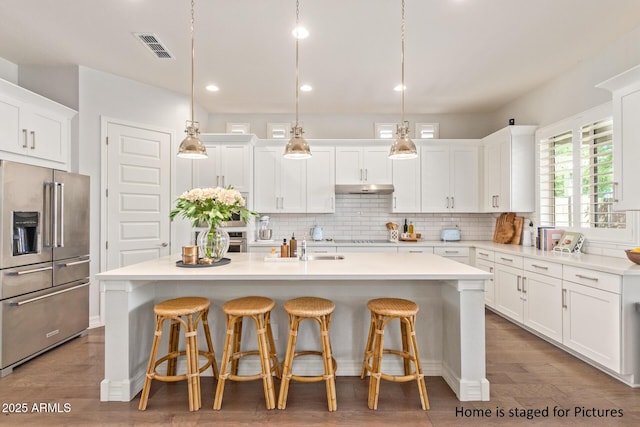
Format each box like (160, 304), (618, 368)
(106, 118), (172, 270)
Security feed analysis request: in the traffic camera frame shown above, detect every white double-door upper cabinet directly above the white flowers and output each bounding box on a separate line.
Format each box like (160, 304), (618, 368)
(193, 134), (251, 193)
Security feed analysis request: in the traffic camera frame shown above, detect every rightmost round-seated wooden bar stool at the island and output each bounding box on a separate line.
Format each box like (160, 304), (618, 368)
(360, 298), (429, 410)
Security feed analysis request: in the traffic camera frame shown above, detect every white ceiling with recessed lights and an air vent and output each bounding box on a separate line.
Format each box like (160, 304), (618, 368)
(0, 0), (640, 114)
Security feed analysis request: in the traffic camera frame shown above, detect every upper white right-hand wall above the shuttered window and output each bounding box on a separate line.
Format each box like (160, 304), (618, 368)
(492, 28), (640, 131)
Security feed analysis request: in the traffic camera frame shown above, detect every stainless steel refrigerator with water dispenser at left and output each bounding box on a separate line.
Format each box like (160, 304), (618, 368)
(0, 160), (90, 377)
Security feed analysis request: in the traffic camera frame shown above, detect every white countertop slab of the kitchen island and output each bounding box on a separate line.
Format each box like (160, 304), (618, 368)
(96, 253), (492, 281)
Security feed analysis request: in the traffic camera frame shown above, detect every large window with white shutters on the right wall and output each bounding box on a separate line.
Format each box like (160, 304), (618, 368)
(536, 104), (632, 240)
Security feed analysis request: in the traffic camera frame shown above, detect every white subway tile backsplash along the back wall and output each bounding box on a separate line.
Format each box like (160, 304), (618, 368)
(255, 194), (495, 241)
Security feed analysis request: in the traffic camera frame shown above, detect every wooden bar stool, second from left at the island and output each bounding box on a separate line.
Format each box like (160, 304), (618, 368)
(213, 297), (280, 410)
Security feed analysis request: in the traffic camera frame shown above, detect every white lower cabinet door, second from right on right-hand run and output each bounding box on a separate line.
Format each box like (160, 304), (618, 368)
(522, 273), (562, 342)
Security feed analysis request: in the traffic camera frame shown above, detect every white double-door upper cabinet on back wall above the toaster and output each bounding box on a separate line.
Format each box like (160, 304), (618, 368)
(420, 141), (479, 212)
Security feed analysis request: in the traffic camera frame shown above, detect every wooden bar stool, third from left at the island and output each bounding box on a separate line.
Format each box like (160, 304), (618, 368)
(278, 297), (338, 411)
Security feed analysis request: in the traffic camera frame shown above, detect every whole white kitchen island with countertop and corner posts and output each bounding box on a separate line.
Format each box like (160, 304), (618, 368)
(96, 253), (491, 401)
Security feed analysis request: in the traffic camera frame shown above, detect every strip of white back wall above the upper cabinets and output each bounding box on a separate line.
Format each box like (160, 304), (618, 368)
(206, 112), (492, 139)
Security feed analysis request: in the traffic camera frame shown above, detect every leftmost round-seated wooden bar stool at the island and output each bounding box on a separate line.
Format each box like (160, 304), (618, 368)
(138, 297), (218, 411)
